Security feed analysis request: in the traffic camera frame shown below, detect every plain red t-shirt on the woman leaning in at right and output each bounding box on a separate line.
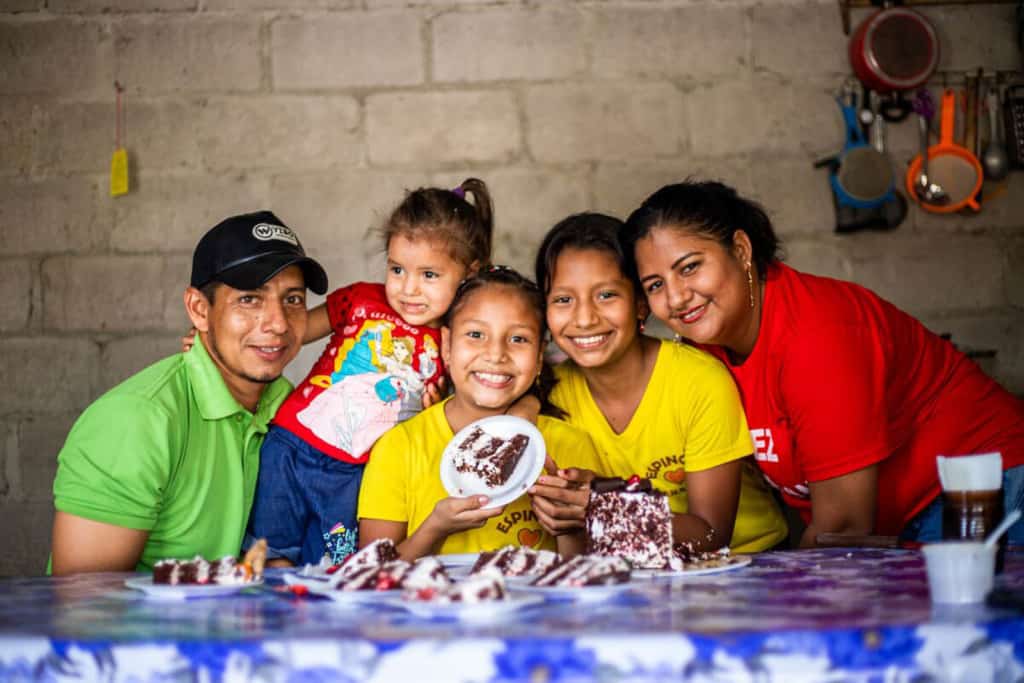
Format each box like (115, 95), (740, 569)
(708, 263), (1024, 535)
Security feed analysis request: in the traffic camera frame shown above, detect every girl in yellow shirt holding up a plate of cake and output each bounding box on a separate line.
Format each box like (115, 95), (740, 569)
(358, 267), (606, 560)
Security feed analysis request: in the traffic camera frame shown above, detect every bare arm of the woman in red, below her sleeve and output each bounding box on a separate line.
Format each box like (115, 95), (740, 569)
(800, 465), (879, 548)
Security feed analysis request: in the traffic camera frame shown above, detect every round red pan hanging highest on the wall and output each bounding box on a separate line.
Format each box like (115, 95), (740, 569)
(849, 6), (939, 122)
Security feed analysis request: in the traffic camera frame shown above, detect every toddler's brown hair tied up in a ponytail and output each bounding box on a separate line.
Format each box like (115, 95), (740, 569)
(381, 178), (495, 268)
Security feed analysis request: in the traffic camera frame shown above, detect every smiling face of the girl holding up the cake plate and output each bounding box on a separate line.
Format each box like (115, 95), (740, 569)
(441, 285), (542, 415)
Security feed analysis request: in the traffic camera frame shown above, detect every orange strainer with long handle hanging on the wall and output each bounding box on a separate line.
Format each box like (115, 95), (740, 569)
(906, 89), (982, 213)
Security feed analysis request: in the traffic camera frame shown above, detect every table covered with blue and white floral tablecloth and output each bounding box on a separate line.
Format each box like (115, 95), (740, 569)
(0, 548), (1024, 683)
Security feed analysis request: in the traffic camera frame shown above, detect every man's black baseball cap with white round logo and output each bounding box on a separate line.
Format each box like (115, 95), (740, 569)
(191, 211), (327, 294)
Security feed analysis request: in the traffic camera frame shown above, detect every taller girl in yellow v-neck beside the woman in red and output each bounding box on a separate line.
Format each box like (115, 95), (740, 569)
(530, 213), (787, 553)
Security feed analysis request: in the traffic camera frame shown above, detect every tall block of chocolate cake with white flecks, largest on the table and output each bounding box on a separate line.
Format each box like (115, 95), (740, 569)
(587, 477), (675, 569)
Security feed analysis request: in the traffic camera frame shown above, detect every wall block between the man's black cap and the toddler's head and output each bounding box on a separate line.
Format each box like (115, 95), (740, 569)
(270, 170), (432, 270)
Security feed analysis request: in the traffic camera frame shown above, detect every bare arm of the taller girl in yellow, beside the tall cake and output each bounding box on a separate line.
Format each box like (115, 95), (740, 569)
(672, 459), (743, 551)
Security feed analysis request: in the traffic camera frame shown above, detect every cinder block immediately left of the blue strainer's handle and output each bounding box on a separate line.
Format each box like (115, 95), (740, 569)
(686, 74), (844, 159)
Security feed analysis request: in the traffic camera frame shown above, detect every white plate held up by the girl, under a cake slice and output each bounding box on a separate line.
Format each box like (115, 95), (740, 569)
(441, 415), (547, 508)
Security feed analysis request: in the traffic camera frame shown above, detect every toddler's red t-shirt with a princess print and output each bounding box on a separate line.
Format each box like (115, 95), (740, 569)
(273, 283), (444, 463)
